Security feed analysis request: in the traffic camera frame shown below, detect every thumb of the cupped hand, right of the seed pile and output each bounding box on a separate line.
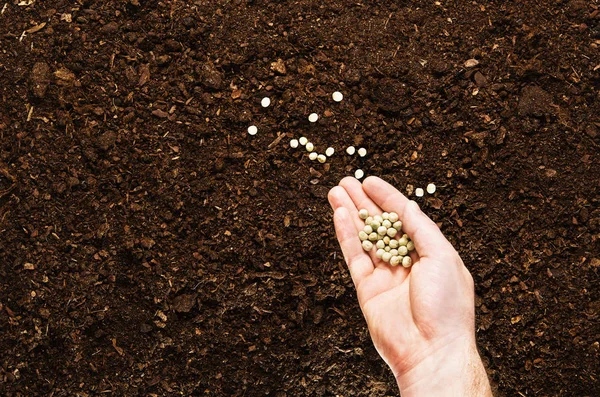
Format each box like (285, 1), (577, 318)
(402, 200), (456, 260)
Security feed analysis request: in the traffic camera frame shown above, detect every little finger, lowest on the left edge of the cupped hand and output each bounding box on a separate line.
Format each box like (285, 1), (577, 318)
(333, 207), (374, 289)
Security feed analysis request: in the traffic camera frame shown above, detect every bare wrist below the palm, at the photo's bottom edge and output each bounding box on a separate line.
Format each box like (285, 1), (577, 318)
(394, 338), (492, 397)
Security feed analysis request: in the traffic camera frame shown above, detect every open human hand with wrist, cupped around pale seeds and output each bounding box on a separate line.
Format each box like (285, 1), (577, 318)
(329, 177), (492, 396)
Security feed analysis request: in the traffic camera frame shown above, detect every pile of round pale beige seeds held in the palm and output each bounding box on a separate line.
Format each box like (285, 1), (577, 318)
(358, 209), (415, 267)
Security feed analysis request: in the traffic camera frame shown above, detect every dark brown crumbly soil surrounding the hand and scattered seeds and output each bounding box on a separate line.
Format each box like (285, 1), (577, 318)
(0, 0), (600, 396)
